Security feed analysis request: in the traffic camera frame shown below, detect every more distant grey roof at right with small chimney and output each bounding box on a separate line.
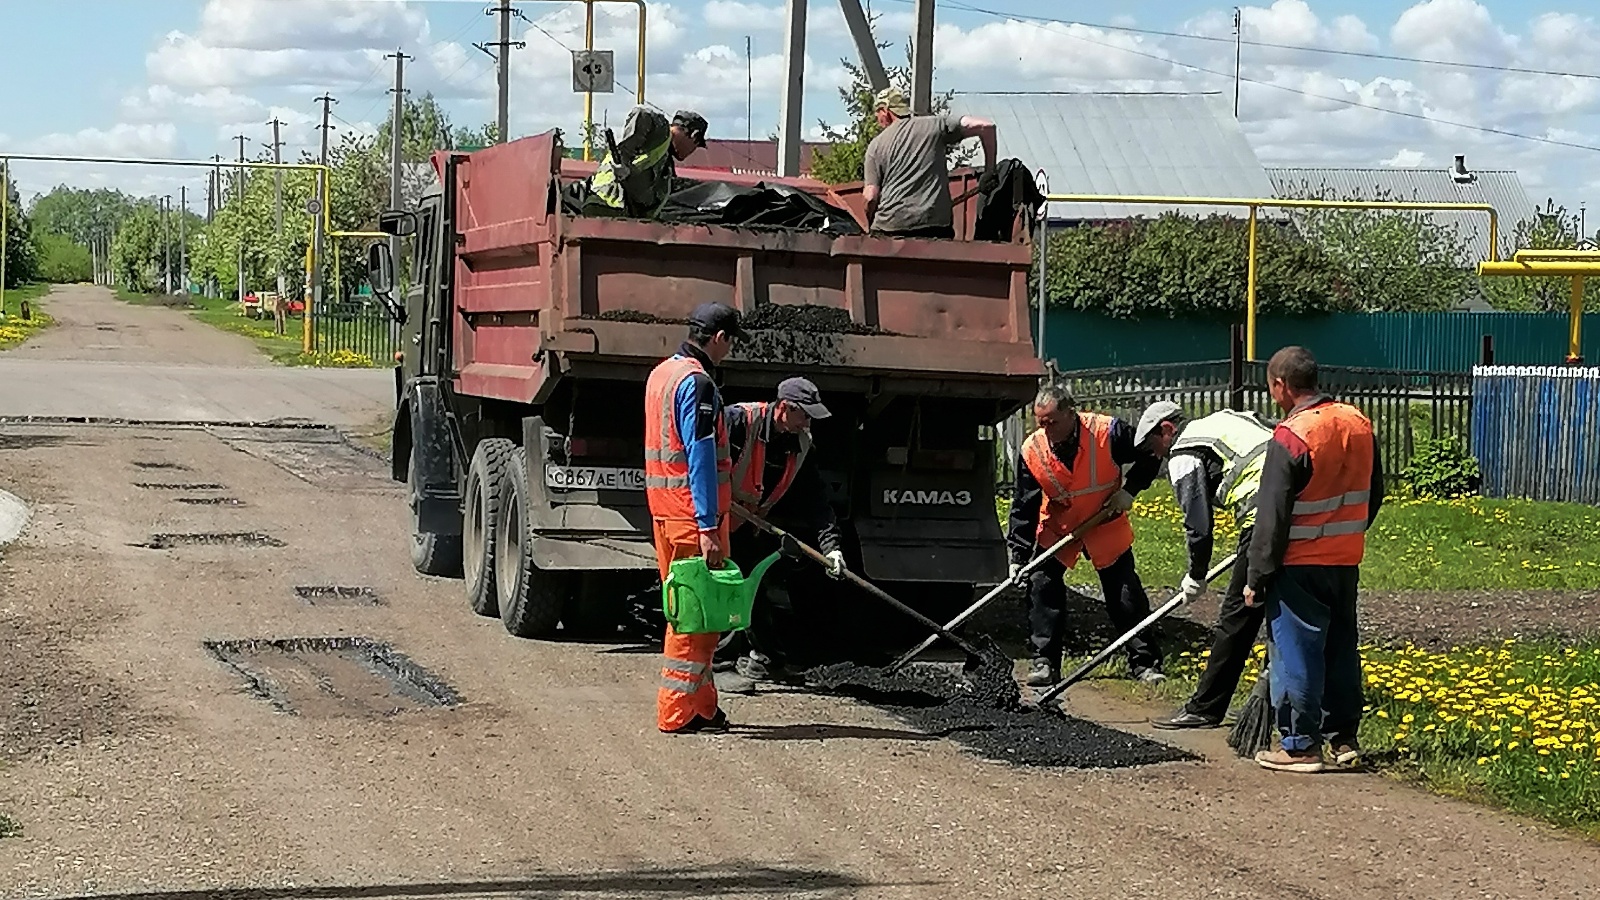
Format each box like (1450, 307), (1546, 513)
(1267, 167), (1534, 261)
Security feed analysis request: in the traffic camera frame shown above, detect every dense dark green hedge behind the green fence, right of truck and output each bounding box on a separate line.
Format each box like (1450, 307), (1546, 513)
(1046, 213), (1360, 319)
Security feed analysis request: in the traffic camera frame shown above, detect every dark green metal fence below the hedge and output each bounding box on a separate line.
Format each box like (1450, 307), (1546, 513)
(1035, 309), (1600, 373)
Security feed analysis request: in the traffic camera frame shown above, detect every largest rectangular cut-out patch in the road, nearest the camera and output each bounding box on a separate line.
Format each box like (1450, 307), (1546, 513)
(203, 637), (461, 717)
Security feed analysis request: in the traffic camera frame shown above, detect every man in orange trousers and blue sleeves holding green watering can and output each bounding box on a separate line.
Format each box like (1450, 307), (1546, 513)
(645, 303), (744, 735)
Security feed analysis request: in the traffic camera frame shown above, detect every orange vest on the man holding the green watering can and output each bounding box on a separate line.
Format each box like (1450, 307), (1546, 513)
(645, 356), (733, 520)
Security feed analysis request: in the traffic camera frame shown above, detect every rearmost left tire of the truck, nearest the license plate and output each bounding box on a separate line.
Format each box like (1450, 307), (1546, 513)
(494, 447), (573, 639)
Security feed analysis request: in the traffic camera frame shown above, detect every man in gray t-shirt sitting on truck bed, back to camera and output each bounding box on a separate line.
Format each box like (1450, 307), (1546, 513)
(861, 88), (995, 237)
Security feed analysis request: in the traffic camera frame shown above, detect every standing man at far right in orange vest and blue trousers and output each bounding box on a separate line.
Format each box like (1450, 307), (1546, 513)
(1245, 348), (1384, 772)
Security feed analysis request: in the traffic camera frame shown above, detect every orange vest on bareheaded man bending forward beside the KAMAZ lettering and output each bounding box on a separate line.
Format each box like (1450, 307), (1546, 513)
(1022, 413), (1133, 569)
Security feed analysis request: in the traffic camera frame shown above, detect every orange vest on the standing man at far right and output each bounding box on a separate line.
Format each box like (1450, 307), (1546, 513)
(1278, 402), (1374, 565)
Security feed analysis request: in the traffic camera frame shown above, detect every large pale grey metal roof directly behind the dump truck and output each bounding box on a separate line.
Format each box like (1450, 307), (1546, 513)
(952, 93), (1272, 219)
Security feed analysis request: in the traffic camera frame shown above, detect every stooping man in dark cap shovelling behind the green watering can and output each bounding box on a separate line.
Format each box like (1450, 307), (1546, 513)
(717, 378), (845, 693)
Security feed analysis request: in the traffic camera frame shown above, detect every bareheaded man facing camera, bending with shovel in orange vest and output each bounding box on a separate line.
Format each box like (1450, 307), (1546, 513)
(1006, 384), (1166, 687)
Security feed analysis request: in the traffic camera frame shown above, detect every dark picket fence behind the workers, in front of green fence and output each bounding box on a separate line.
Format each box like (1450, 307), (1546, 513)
(997, 329), (1472, 484)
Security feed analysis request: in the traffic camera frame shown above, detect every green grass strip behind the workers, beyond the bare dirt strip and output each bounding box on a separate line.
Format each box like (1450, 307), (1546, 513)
(998, 482), (1600, 591)
